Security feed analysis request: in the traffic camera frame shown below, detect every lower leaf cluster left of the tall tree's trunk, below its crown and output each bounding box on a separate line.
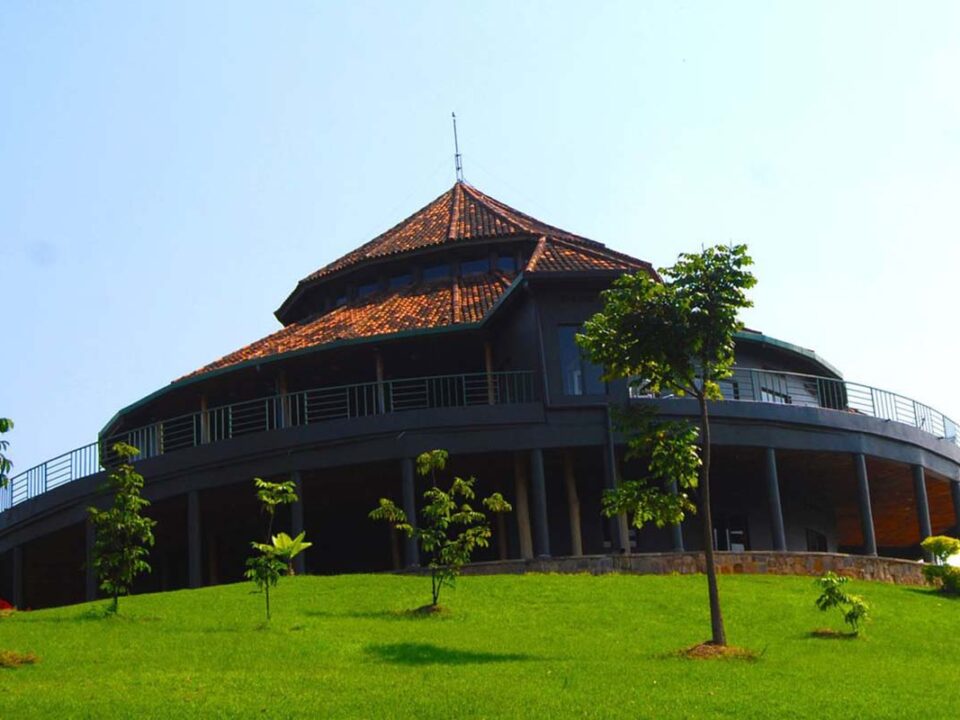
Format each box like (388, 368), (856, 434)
(602, 408), (701, 528)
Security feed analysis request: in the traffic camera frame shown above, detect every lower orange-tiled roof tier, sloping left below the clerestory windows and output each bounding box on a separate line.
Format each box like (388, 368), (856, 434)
(185, 272), (510, 377)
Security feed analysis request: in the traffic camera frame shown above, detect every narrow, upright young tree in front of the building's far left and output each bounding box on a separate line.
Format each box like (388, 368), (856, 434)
(87, 442), (157, 613)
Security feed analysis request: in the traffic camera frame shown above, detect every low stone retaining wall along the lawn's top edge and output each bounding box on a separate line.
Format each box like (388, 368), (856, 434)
(454, 552), (924, 585)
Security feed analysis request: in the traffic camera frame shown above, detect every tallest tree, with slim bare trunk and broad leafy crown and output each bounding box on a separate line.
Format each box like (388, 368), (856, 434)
(578, 245), (756, 645)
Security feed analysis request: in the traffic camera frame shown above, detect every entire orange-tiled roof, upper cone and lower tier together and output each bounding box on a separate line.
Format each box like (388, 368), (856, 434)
(181, 182), (654, 379)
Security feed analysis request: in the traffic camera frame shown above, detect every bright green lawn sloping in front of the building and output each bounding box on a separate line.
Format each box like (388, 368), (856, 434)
(0, 575), (960, 720)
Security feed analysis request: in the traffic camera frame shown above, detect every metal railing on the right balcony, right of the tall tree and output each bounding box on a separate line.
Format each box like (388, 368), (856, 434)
(630, 367), (960, 445)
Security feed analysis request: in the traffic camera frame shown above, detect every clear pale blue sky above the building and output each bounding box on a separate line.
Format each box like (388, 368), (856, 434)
(0, 0), (960, 472)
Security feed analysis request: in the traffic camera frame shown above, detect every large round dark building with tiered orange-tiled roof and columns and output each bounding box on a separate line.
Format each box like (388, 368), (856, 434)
(0, 182), (960, 607)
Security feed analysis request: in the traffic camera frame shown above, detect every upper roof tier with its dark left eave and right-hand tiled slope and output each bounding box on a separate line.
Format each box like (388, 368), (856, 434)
(276, 181), (652, 325)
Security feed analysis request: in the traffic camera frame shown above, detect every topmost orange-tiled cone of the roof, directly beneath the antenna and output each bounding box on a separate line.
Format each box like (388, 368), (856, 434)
(301, 182), (603, 283)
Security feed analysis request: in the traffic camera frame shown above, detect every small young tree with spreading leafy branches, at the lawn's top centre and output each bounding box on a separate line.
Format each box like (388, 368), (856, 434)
(370, 450), (513, 610)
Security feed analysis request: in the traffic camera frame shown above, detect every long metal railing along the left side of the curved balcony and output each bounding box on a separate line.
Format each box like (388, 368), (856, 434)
(0, 371), (536, 512)
